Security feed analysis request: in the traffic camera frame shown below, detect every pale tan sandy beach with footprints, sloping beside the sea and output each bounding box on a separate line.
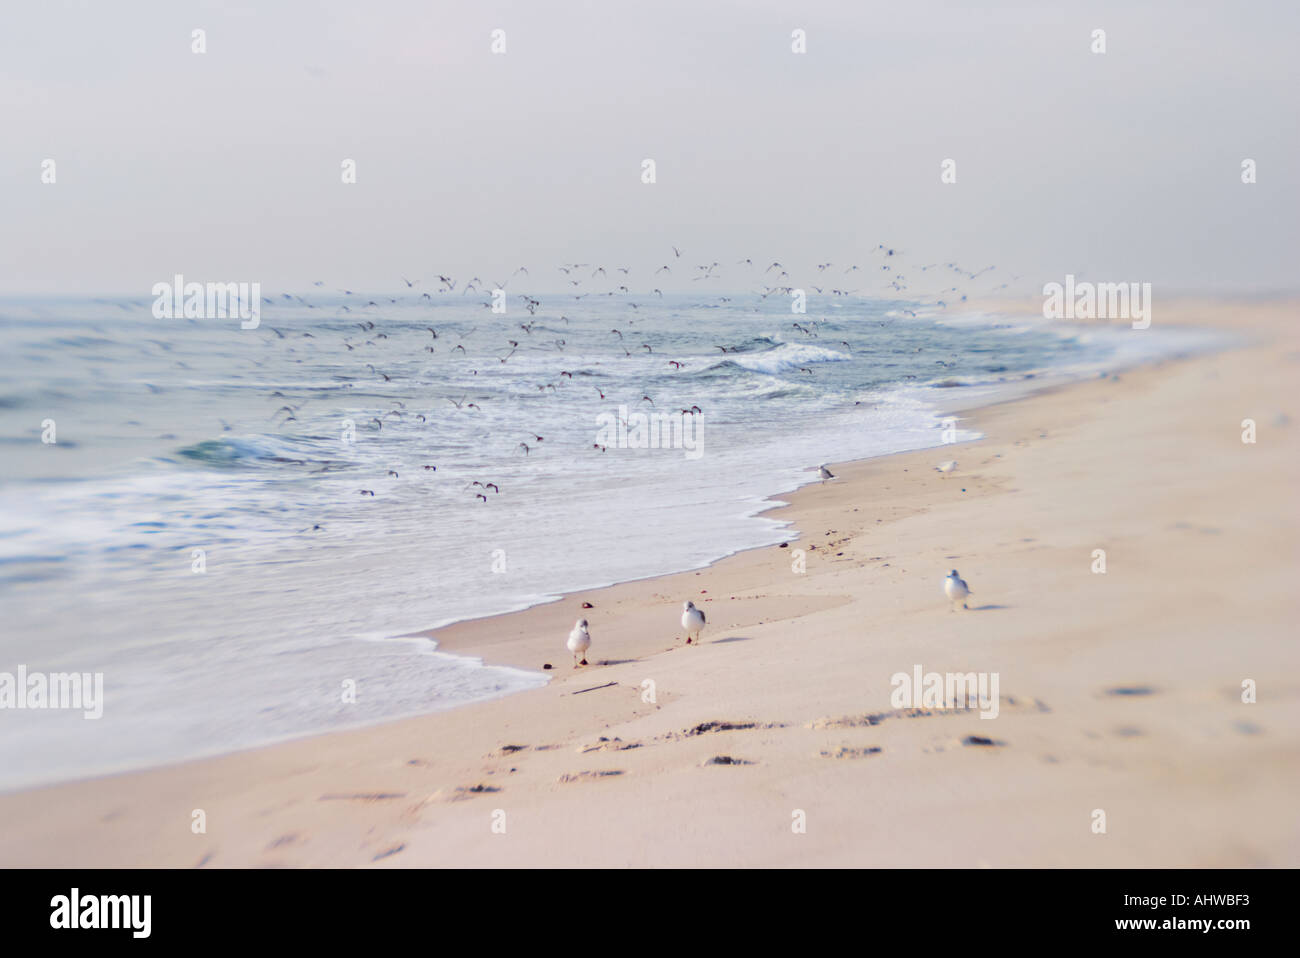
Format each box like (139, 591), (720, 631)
(0, 300), (1300, 867)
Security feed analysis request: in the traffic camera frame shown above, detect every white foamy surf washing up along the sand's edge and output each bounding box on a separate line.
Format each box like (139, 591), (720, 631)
(0, 293), (1164, 792)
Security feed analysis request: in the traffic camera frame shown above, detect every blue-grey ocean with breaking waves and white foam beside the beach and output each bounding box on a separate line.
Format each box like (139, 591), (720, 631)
(0, 290), (1208, 789)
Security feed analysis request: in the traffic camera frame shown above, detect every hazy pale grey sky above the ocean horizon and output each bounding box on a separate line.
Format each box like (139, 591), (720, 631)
(0, 0), (1300, 298)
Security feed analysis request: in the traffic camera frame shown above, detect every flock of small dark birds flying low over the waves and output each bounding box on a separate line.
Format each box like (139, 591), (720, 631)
(245, 243), (1018, 503)
